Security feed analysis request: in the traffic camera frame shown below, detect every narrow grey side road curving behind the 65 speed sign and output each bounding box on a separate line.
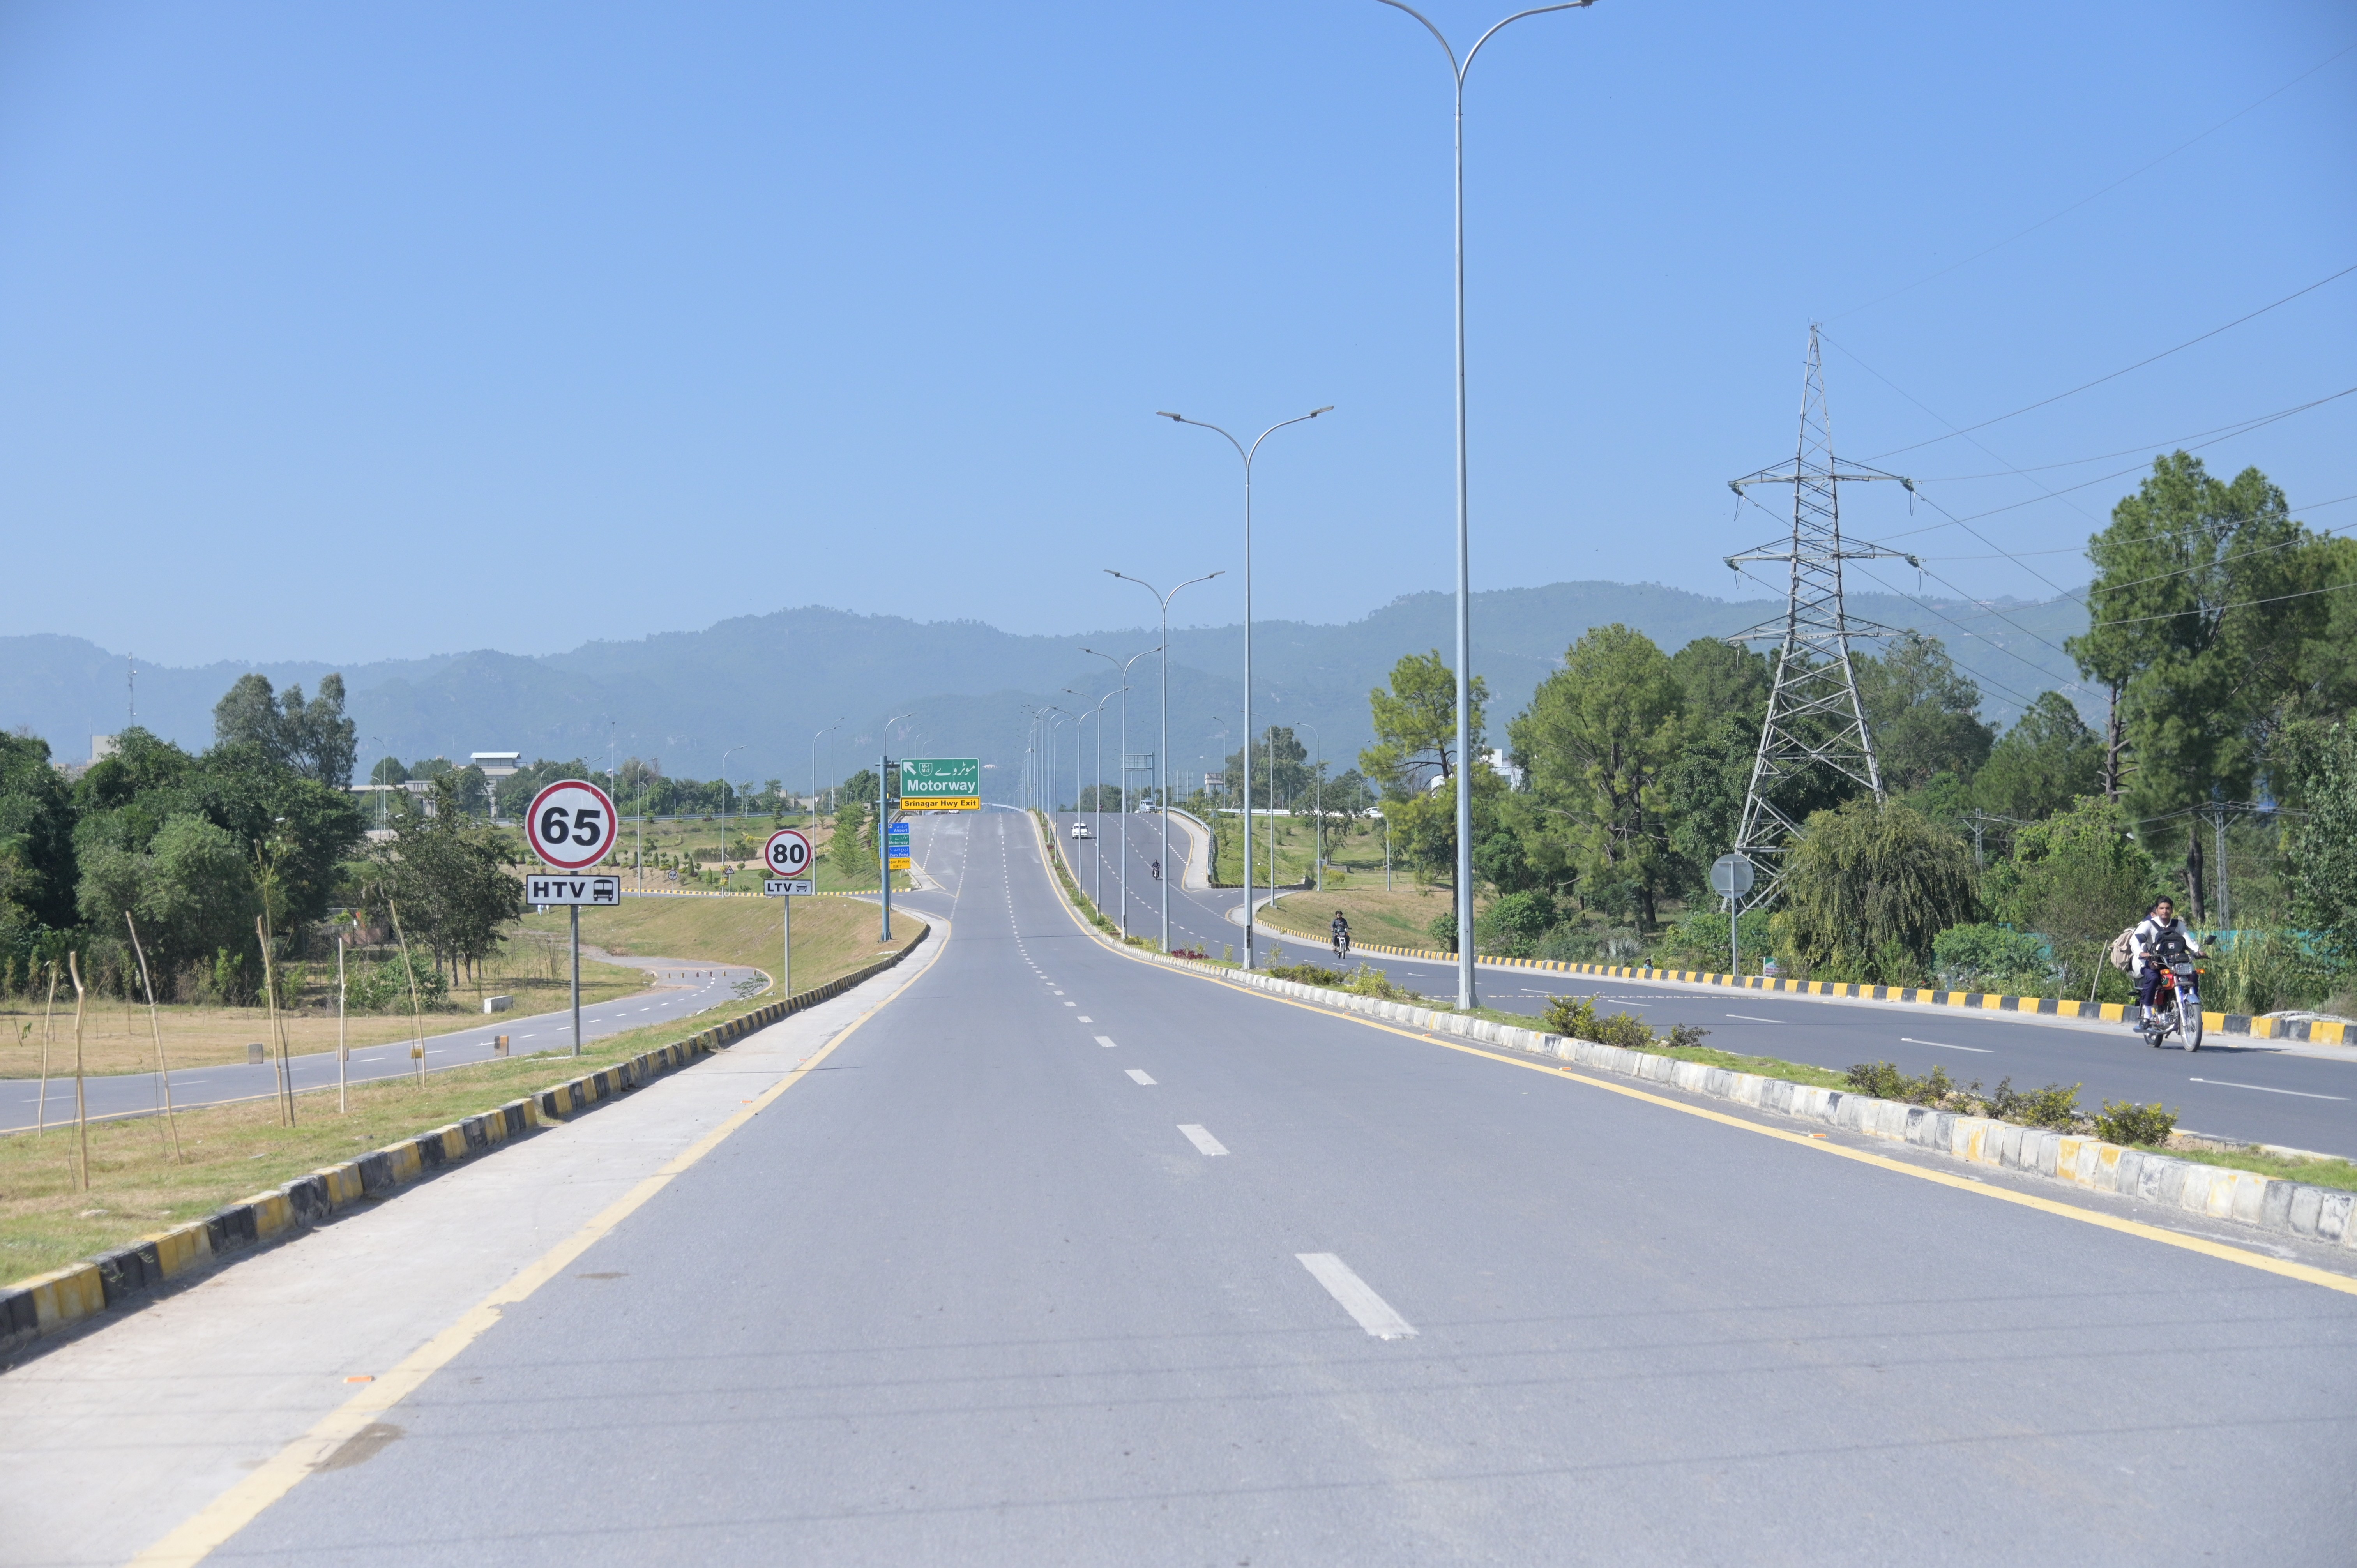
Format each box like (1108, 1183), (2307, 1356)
(0, 957), (769, 1132)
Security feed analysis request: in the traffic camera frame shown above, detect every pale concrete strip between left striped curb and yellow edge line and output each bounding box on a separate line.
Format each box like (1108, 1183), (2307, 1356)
(0, 927), (947, 1566)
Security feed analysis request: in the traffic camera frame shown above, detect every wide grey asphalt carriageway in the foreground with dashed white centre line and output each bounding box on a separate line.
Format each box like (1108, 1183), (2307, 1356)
(203, 811), (2357, 1568)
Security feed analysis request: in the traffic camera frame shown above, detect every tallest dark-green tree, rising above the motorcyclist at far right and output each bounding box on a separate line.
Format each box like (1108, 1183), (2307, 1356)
(2067, 453), (2350, 818)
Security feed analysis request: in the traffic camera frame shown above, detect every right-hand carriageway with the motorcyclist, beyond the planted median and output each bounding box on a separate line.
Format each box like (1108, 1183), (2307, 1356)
(1058, 816), (2357, 1158)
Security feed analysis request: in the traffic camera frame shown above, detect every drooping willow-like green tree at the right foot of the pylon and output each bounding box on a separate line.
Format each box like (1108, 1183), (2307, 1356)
(1772, 797), (1980, 985)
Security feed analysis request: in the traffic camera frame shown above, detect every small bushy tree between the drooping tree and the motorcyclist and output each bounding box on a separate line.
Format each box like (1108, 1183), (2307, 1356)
(1987, 795), (2161, 988)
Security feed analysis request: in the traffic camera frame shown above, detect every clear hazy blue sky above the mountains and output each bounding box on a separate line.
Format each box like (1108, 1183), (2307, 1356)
(0, 0), (2357, 662)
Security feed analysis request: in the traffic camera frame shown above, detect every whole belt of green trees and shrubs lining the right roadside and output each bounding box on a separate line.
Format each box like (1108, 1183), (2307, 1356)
(1169, 453), (2357, 1033)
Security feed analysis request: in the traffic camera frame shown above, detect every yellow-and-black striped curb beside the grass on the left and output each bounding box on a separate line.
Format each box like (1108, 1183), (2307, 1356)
(0, 920), (931, 1351)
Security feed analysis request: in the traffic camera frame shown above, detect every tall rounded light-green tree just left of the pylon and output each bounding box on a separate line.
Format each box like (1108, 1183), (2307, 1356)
(1509, 622), (1685, 927)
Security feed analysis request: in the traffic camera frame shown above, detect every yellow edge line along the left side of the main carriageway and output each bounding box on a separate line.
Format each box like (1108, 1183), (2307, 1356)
(130, 920), (950, 1568)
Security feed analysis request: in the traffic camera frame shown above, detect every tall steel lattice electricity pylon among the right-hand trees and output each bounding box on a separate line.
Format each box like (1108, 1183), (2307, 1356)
(1728, 325), (1921, 908)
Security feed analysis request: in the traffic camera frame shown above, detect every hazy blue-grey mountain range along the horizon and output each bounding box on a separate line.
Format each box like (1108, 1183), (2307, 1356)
(0, 583), (2093, 799)
